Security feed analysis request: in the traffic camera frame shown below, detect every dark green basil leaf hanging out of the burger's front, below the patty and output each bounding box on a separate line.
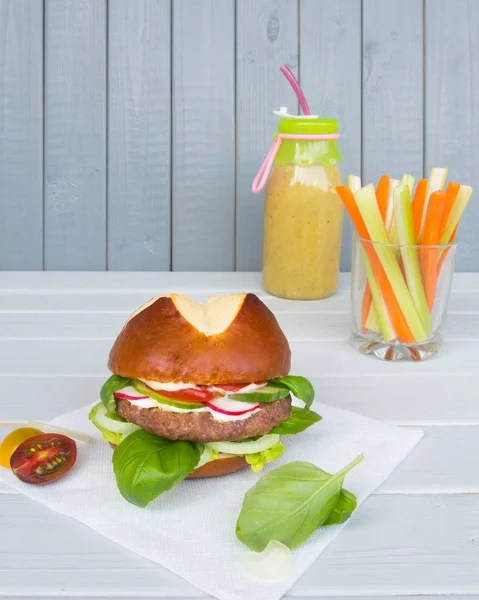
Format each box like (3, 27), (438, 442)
(112, 429), (201, 506)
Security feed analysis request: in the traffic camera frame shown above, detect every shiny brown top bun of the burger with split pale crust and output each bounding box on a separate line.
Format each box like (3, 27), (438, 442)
(108, 294), (291, 385)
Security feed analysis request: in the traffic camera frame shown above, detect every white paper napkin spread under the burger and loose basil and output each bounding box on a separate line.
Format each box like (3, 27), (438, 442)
(1, 403), (423, 600)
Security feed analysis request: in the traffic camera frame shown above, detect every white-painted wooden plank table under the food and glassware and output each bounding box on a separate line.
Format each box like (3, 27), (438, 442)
(0, 272), (479, 600)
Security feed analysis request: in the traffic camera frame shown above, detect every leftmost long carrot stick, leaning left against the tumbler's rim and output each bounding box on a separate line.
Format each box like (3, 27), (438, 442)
(336, 186), (416, 344)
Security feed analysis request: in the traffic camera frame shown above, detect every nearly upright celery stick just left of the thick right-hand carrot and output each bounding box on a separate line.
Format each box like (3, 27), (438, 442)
(394, 185), (432, 332)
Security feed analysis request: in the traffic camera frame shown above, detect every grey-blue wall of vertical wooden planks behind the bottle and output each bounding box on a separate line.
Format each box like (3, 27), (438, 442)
(0, 0), (479, 271)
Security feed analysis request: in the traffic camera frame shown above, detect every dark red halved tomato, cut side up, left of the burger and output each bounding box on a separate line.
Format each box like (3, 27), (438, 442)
(10, 433), (77, 484)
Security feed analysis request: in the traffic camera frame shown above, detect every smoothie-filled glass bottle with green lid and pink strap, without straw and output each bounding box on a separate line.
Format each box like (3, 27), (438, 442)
(253, 115), (343, 300)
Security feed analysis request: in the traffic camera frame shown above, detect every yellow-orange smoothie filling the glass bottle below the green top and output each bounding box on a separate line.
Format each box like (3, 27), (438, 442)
(263, 164), (343, 300)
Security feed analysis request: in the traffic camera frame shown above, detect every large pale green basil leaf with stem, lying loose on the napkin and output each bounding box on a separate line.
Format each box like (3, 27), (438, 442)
(236, 455), (363, 552)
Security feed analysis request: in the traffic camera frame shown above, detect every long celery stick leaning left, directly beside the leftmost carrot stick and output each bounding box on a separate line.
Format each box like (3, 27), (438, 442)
(354, 184), (427, 342)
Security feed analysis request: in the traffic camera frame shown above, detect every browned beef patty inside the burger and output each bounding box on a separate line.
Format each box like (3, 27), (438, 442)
(116, 396), (291, 443)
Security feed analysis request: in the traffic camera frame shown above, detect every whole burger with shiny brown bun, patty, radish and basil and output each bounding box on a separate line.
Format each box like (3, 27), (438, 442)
(90, 294), (321, 506)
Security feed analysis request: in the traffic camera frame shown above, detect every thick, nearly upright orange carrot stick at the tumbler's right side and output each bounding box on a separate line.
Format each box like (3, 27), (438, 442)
(419, 191), (447, 311)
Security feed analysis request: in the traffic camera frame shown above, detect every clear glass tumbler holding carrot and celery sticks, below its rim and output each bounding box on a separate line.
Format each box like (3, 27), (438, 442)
(351, 235), (456, 361)
